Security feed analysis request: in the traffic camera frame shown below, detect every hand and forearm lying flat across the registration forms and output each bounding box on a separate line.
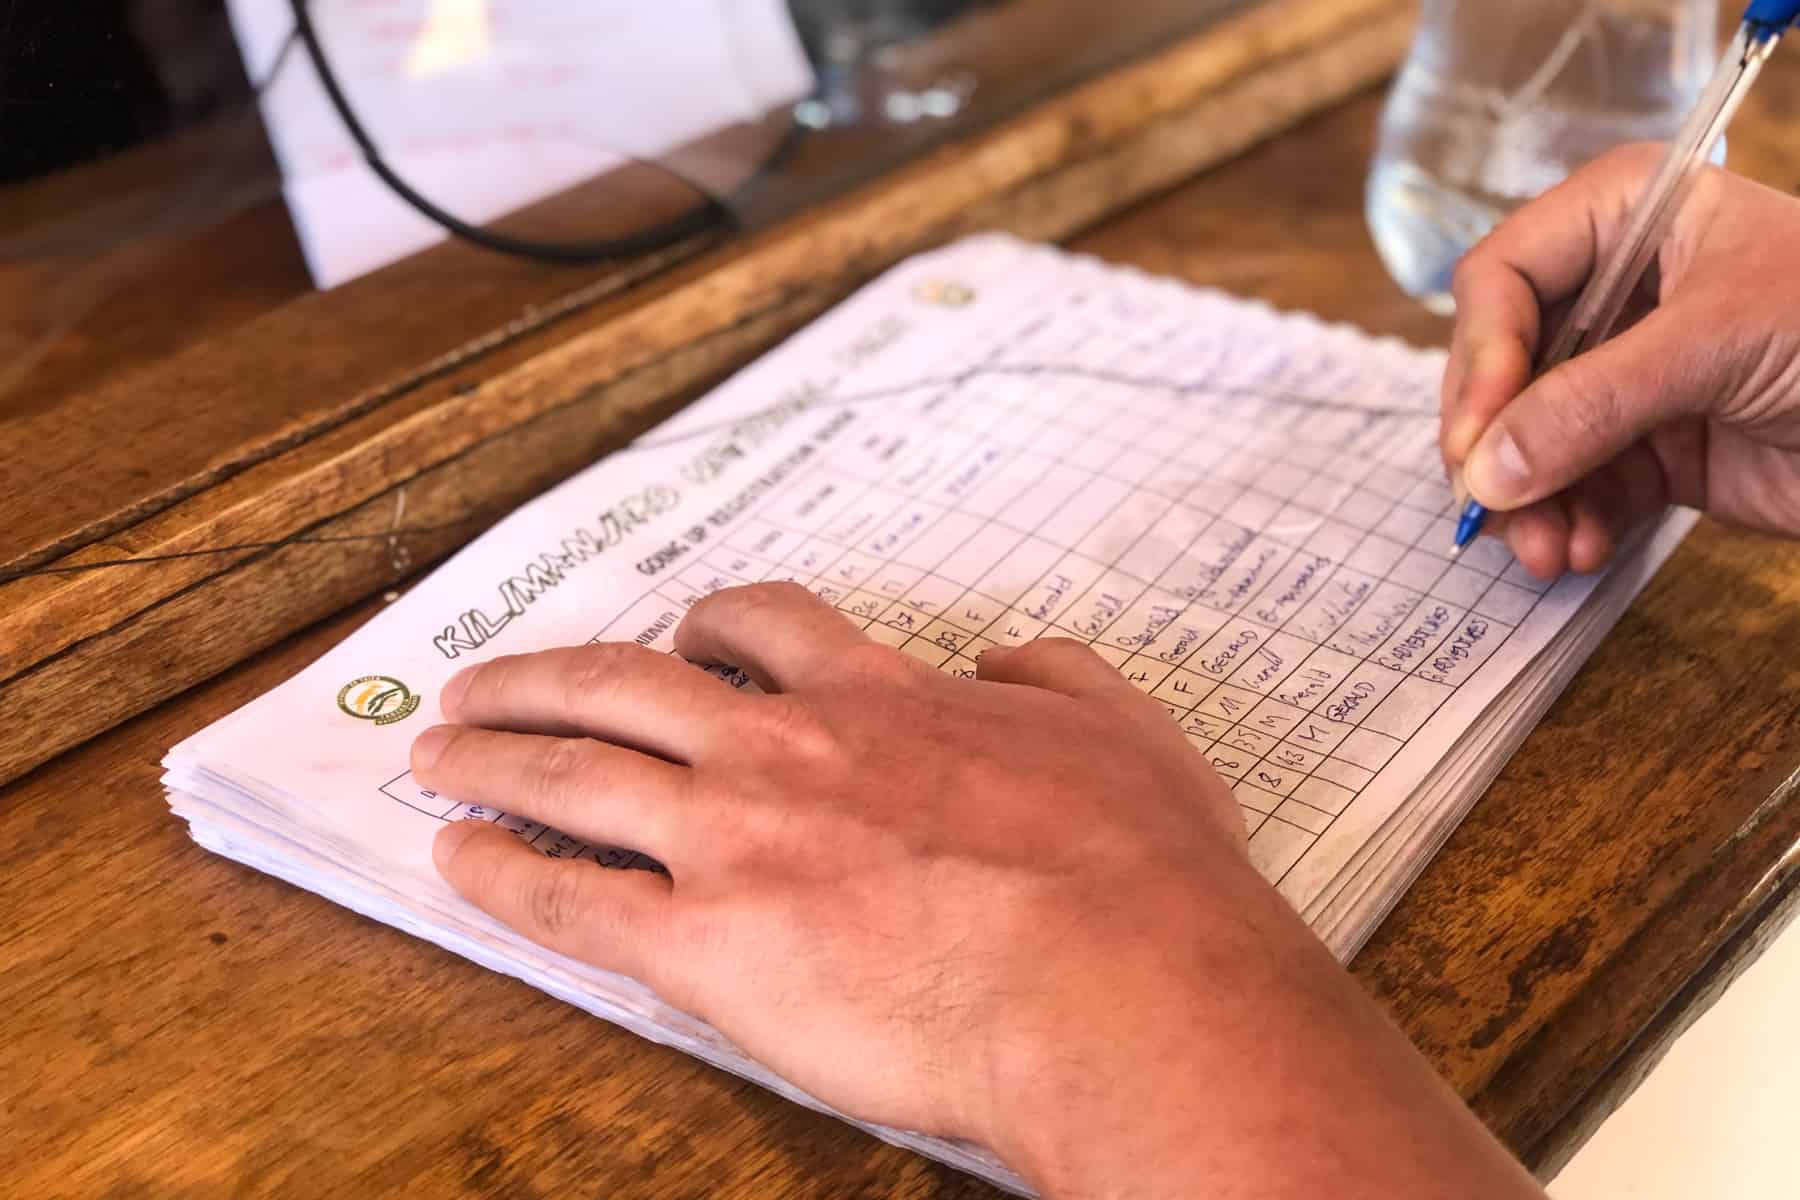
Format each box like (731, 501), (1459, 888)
(412, 585), (1541, 1196)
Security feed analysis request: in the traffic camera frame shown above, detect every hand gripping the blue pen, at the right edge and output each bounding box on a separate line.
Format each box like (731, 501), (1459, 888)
(1440, 146), (1800, 576)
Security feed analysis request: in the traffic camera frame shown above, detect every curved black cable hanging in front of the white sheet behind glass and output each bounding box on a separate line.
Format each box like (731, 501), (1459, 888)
(286, 0), (805, 263)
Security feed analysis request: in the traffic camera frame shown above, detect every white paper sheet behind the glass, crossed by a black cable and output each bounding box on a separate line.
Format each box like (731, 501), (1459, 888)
(229, 0), (812, 288)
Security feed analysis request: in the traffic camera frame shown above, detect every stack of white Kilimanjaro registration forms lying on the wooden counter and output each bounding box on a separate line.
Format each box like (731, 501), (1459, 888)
(166, 237), (1690, 1187)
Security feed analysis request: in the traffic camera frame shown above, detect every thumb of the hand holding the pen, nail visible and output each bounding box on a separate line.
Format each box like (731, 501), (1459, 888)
(1463, 308), (1726, 511)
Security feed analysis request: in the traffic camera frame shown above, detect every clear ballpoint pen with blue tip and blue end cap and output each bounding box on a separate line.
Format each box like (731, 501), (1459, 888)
(1451, 0), (1800, 558)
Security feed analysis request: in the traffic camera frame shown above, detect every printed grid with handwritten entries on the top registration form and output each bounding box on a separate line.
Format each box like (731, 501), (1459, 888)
(383, 255), (1546, 882)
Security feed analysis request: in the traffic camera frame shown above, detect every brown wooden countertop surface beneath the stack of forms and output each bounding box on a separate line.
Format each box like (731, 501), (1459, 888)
(0, 16), (1800, 1196)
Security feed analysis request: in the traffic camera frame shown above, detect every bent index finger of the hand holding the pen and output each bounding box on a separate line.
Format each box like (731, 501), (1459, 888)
(1438, 146), (1658, 466)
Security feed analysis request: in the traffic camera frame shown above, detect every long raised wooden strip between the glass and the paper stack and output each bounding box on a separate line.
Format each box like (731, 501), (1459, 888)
(0, 0), (1411, 779)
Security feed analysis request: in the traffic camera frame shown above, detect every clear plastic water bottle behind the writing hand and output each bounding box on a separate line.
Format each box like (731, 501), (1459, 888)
(1366, 0), (1723, 313)
